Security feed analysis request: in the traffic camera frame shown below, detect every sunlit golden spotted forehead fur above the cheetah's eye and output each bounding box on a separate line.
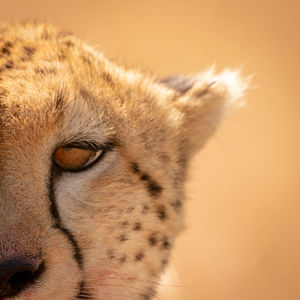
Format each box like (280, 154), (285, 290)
(0, 23), (181, 157)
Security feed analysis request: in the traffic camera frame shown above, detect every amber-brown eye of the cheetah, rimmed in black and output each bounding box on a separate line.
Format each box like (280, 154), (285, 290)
(54, 147), (103, 171)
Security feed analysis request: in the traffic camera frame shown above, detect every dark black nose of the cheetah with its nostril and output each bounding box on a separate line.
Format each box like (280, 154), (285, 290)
(0, 257), (45, 300)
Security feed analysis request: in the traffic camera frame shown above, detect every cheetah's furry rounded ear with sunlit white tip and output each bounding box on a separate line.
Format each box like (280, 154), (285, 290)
(160, 70), (248, 157)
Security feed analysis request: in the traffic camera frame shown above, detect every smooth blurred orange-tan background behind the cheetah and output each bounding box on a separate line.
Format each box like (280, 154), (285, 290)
(0, 0), (300, 300)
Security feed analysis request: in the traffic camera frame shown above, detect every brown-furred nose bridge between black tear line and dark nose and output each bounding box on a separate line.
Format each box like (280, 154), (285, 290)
(0, 155), (51, 264)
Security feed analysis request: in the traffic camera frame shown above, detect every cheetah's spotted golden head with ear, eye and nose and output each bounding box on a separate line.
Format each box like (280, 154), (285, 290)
(0, 22), (247, 300)
